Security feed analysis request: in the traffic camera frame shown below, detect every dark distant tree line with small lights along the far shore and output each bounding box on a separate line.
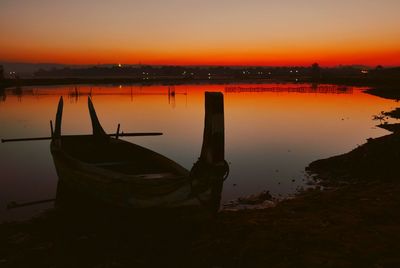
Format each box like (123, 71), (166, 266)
(30, 63), (400, 82)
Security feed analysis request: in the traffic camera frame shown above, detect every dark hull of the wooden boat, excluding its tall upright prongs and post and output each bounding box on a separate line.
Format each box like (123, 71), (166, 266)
(51, 137), (220, 209)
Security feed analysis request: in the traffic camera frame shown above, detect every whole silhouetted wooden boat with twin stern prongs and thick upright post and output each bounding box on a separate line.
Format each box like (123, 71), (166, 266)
(50, 92), (228, 213)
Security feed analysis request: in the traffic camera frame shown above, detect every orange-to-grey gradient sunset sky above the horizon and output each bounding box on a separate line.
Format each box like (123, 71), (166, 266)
(0, 0), (400, 65)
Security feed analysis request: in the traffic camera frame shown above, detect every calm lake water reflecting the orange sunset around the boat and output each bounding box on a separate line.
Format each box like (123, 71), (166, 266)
(0, 84), (396, 221)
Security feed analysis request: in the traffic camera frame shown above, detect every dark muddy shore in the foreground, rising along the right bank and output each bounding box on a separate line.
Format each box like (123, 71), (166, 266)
(0, 87), (400, 267)
